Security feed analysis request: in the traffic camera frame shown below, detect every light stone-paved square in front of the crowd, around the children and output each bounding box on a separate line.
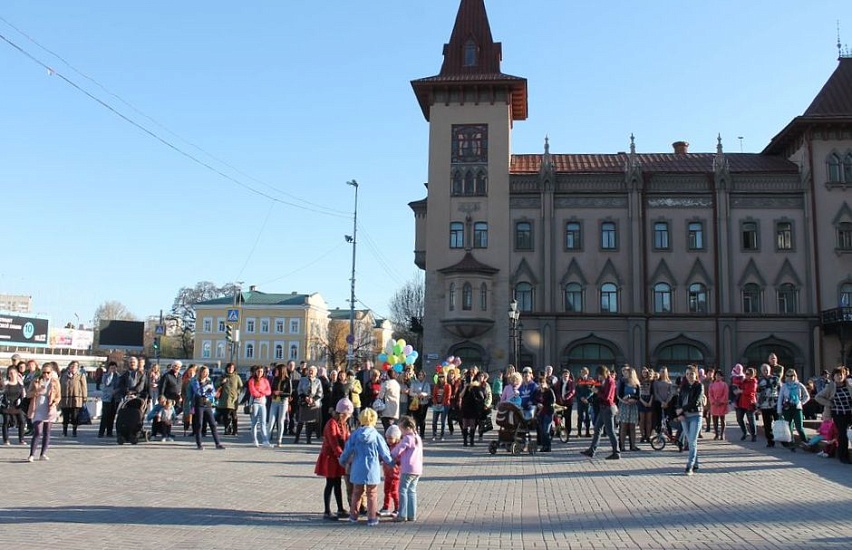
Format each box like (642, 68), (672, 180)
(0, 422), (852, 550)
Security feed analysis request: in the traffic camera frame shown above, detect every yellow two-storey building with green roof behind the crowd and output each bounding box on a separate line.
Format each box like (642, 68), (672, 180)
(193, 286), (328, 368)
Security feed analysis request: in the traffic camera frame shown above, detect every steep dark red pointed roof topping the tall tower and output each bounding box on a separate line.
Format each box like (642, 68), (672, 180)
(411, 0), (528, 120)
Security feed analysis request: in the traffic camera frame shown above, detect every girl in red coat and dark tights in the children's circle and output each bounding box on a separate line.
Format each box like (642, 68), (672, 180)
(314, 397), (354, 521)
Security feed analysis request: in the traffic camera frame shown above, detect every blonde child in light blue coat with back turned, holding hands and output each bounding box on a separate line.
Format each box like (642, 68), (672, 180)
(338, 408), (393, 527)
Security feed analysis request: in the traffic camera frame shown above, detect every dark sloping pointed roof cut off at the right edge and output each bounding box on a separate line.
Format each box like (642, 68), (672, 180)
(763, 57), (852, 154)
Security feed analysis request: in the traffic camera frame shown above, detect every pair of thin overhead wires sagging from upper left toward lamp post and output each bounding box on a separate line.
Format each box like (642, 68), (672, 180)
(0, 26), (349, 218)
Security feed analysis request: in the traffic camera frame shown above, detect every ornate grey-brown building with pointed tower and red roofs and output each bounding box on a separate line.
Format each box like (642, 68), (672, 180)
(410, 0), (852, 375)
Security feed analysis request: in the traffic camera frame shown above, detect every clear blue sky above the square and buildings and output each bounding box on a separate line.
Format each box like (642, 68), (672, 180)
(0, 0), (852, 324)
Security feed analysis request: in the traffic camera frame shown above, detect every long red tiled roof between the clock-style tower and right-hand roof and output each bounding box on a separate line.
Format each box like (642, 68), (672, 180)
(509, 153), (798, 174)
